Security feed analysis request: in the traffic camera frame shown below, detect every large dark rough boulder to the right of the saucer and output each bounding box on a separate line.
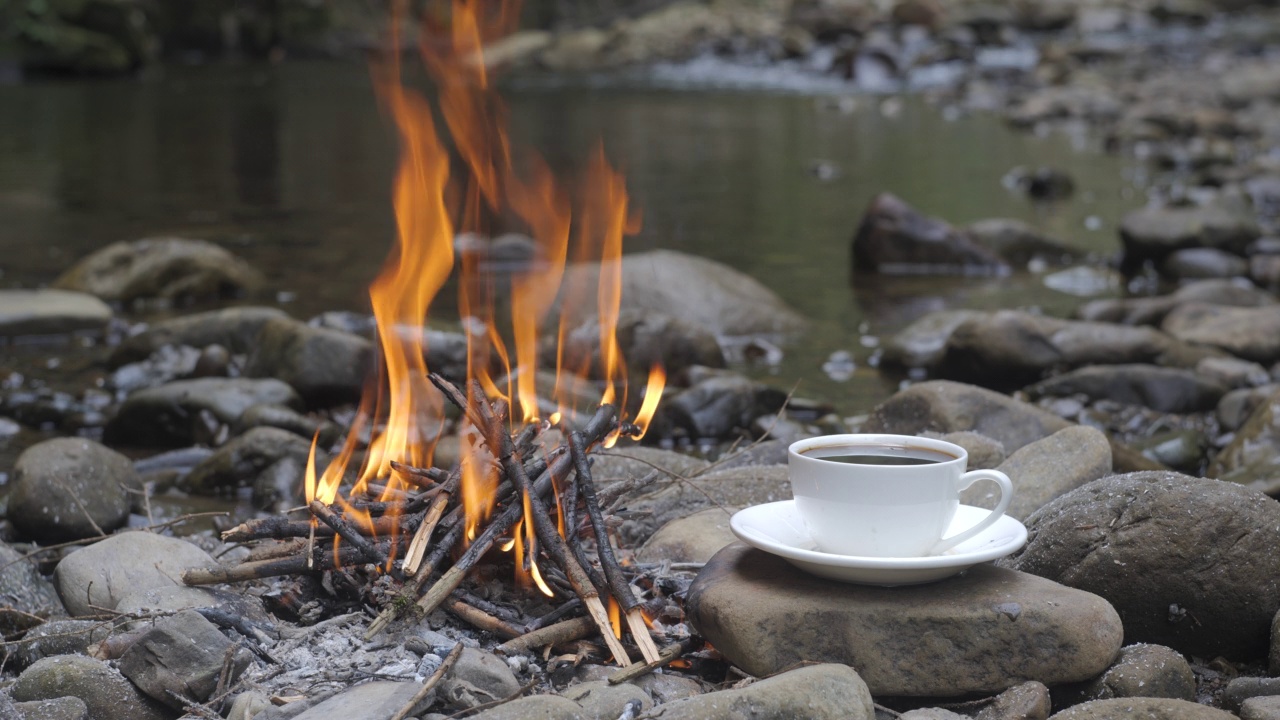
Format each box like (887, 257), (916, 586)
(1000, 471), (1280, 660)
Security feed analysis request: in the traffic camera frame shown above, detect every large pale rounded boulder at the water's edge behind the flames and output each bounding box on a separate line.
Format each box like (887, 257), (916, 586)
(561, 250), (808, 336)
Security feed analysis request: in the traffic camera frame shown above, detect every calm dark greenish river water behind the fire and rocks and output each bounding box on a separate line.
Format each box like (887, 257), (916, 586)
(0, 64), (1140, 414)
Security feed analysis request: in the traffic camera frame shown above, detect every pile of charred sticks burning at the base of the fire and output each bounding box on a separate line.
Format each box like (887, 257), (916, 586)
(183, 374), (662, 665)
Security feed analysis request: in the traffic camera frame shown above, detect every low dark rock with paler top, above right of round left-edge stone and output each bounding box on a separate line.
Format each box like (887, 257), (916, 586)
(104, 378), (301, 447)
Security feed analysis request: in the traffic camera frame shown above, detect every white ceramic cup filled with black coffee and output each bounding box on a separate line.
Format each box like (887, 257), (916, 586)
(787, 434), (1014, 557)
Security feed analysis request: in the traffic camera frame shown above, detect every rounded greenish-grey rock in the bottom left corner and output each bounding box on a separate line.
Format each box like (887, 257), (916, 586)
(9, 655), (175, 720)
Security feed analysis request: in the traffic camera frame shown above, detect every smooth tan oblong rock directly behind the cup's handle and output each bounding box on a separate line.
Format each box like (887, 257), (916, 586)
(960, 425), (1111, 520)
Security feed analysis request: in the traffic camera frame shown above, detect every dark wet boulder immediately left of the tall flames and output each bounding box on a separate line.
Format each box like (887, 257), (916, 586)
(244, 319), (374, 407)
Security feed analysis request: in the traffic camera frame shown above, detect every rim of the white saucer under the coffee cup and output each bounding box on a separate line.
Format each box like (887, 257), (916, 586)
(730, 498), (1027, 570)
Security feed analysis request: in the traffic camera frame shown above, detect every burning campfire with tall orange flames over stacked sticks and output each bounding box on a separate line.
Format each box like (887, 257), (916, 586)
(184, 0), (669, 665)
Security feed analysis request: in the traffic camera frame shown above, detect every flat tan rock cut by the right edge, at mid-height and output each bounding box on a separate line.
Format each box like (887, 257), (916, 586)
(1161, 302), (1280, 365)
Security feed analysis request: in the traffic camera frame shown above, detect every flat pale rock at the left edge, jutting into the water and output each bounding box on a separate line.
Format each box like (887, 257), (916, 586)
(0, 290), (111, 338)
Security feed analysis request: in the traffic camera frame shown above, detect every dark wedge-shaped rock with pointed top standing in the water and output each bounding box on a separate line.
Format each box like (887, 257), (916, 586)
(852, 193), (1009, 275)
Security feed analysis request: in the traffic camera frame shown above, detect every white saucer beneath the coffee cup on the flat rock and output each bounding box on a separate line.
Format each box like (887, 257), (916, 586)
(730, 500), (1027, 585)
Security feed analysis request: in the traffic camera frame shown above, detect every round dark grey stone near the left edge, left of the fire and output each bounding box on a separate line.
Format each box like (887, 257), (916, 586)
(8, 438), (141, 543)
